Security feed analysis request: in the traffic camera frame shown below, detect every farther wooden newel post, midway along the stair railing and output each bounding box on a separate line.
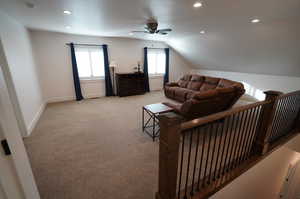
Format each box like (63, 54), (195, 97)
(255, 91), (282, 155)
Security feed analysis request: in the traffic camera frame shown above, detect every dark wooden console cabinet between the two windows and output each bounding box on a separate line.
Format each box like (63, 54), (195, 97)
(116, 73), (145, 97)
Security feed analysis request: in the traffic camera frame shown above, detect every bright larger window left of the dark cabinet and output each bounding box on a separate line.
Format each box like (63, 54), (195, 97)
(75, 46), (105, 79)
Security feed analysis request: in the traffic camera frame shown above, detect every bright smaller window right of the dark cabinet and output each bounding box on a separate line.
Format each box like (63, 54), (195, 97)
(148, 49), (166, 75)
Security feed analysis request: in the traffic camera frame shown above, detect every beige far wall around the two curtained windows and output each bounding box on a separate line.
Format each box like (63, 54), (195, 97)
(30, 30), (190, 102)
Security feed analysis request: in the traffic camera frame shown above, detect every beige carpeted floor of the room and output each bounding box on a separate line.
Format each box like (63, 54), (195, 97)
(25, 92), (252, 199)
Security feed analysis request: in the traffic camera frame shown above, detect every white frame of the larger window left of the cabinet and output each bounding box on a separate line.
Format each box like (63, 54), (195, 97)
(75, 45), (105, 81)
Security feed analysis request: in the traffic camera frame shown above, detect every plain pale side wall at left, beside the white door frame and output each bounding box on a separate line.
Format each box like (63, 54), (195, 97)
(0, 12), (44, 136)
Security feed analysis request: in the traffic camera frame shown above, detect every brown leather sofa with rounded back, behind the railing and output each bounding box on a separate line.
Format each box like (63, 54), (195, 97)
(164, 74), (245, 119)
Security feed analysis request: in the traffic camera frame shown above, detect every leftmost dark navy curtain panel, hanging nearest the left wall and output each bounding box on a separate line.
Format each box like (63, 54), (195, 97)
(70, 43), (83, 101)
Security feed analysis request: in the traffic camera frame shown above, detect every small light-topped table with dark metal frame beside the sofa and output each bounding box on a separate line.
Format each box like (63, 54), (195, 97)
(142, 103), (173, 142)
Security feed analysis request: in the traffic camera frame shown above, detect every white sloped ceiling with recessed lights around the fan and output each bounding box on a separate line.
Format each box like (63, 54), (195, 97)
(0, 0), (300, 76)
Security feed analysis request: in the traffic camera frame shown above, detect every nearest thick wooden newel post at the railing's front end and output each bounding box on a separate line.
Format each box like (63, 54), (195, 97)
(156, 112), (182, 199)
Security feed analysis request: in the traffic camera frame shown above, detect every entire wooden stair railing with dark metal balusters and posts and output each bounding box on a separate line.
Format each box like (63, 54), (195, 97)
(156, 91), (300, 199)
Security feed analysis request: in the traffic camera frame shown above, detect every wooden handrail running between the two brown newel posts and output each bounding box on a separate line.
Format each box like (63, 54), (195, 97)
(181, 101), (271, 131)
